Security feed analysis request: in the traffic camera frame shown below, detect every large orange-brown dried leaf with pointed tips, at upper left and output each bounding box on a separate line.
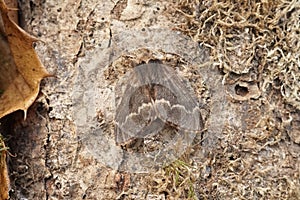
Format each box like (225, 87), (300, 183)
(0, 0), (50, 118)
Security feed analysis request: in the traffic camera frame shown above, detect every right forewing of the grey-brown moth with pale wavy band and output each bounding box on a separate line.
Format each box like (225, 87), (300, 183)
(146, 64), (204, 132)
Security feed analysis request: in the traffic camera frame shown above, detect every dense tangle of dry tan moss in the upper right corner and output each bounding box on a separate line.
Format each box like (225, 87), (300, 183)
(173, 0), (300, 109)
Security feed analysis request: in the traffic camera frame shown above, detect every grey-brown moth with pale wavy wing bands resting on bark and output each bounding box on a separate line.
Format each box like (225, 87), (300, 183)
(115, 63), (203, 145)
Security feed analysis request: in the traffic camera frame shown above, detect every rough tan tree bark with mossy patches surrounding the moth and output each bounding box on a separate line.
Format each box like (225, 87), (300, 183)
(2, 0), (300, 200)
